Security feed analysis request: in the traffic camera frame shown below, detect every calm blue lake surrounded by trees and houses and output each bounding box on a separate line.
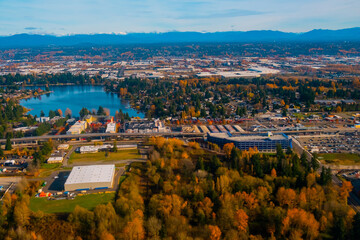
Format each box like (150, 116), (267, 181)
(20, 86), (144, 117)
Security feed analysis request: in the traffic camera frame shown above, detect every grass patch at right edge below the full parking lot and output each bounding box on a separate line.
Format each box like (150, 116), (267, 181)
(318, 153), (360, 165)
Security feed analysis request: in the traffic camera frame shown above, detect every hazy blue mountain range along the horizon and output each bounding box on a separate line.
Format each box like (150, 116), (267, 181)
(0, 28), (360, 48)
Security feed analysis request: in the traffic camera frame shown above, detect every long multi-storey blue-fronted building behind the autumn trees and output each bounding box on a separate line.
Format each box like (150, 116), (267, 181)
(207, 133), (292, 152)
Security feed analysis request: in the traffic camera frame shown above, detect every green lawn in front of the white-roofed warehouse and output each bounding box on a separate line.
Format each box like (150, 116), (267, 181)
(30, 193), (115, 213)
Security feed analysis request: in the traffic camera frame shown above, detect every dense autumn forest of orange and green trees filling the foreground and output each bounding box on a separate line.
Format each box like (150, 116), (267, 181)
(0, 137), (360, 240)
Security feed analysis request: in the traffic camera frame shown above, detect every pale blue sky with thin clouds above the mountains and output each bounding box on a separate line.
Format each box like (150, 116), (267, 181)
(0, 0), (360, 35)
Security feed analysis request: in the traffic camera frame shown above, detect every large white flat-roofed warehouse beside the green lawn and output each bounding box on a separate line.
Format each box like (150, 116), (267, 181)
(64, 164), (115, 191)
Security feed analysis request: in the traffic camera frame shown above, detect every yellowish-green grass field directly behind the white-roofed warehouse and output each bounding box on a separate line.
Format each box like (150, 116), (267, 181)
(69, 149), (141, 164)
